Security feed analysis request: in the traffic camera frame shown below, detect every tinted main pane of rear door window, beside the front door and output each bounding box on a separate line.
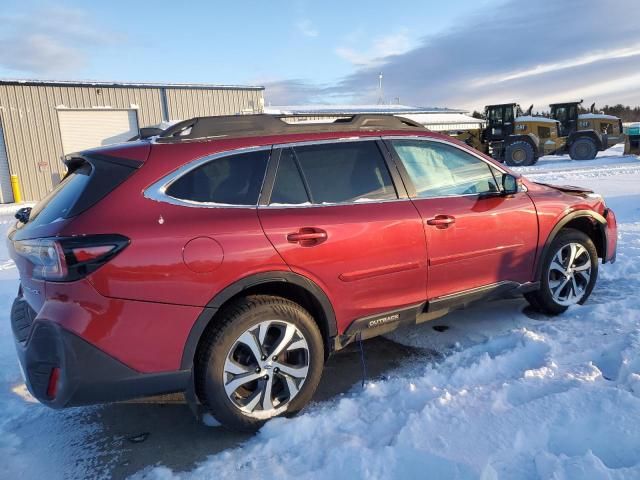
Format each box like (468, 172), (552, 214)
(293, 141), (398, 204)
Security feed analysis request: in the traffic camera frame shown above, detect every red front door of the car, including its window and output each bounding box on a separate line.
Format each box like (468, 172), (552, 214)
(388, 140), (538, 299)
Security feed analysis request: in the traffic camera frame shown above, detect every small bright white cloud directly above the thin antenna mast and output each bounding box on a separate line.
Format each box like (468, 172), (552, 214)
(335, 29), (413, 68)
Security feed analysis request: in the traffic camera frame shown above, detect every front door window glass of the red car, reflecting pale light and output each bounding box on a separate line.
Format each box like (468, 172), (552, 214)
(391, 140), (500, 198)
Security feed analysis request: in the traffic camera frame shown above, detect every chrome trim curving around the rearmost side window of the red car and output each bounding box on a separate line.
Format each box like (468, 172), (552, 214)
(143, 145), (272, 209)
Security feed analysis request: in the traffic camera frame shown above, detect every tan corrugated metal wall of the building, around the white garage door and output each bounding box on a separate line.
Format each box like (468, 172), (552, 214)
(0, 83), (263, 200)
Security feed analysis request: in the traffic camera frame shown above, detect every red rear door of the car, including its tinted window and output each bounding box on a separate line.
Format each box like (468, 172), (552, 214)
(259, 139), (427, 331)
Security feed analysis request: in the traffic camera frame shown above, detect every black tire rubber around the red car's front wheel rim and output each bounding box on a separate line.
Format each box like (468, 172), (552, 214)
(531, 229), (598, 314)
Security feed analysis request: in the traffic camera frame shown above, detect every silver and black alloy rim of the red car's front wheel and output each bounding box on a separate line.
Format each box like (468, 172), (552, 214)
(548, 242), (591, 306)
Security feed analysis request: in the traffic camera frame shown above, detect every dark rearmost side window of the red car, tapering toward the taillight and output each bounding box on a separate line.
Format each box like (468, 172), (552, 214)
(166, 150), (269, 205)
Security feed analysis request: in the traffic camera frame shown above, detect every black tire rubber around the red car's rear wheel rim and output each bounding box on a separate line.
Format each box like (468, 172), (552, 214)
(198, 296), (324, 431)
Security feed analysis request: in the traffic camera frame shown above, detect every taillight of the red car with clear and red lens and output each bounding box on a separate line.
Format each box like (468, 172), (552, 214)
(13, 235), (129, 282)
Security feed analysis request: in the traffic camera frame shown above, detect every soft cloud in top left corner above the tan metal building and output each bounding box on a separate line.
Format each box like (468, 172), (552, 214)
(0, 8), (122, 75)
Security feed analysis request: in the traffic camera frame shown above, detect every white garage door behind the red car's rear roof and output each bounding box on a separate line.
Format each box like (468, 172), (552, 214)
(58, 108), (138, 155)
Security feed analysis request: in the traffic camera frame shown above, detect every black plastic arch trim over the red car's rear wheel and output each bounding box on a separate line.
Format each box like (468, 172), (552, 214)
(180, 270), (338, 369)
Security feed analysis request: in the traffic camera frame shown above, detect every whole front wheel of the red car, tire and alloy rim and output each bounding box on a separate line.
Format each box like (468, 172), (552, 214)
(525, 228), (598, 315)
